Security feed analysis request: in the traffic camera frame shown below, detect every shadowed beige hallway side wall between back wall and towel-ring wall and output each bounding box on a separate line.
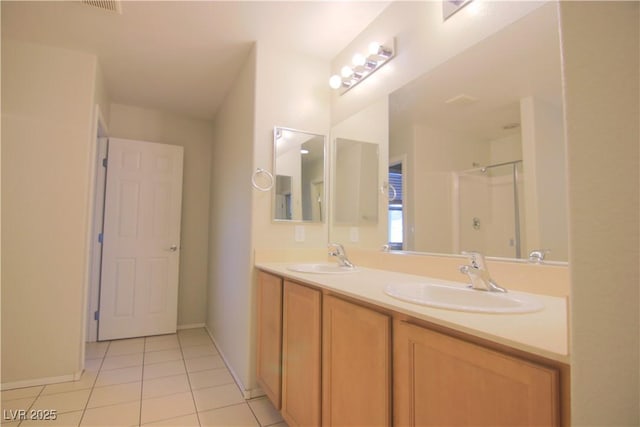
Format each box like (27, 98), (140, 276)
(207, 48), (254, 390)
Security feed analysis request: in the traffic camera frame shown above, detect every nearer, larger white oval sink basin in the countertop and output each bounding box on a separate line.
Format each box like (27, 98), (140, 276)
(384, 282), (544, 313)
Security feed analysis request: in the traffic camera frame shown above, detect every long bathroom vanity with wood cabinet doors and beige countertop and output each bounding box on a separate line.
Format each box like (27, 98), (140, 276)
(256, 263), (569, 426)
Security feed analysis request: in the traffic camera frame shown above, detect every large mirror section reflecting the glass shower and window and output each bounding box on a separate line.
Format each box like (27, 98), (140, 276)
(388, 3), (568, 261)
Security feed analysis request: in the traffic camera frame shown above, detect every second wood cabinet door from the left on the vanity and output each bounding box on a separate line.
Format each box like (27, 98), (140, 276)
(282, 280), (321, 427)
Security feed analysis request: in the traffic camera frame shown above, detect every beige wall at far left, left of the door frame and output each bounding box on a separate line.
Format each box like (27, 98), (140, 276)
(2, 39), (96, 388)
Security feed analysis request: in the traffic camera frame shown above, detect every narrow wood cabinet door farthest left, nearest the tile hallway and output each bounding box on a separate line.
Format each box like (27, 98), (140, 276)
(257, 271), (282, 409)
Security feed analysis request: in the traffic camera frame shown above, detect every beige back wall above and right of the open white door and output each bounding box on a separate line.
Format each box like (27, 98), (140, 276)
(108, 104), (213, 327)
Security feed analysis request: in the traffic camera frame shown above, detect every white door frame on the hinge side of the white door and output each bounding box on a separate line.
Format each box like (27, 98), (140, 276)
(82, 104), (108, 344)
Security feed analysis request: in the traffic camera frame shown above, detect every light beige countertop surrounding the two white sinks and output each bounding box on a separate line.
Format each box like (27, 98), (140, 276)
(256, 262), (569, 364)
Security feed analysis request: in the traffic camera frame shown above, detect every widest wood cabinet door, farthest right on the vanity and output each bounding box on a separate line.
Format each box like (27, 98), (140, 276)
(394, 321), (560, 426)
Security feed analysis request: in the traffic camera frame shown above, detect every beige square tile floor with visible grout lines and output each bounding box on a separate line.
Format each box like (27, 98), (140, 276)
(0, 329), (286, 427)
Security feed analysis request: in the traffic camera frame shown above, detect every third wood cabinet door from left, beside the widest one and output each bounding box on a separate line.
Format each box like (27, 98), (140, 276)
(322, 296), (391, 427)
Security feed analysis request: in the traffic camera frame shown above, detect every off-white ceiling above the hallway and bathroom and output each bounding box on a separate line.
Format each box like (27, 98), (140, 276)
(1, 0), (389, 119)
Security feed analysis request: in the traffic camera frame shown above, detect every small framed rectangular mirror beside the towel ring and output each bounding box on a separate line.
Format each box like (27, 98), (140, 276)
(272, 127), (326, 222)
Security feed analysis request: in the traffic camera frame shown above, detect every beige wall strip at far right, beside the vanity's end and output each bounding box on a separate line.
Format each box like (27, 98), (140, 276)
(560, 2), (640, 426)
